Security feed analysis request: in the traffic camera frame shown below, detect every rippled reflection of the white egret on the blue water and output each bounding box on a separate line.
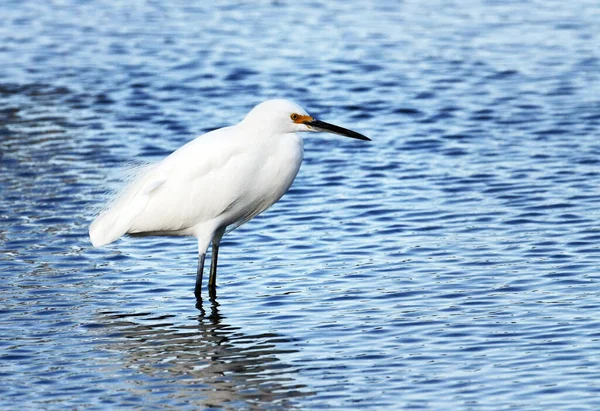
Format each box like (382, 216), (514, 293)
(100, 298), (310, 409)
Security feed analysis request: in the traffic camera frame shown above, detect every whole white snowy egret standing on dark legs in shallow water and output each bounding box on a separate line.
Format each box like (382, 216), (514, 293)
(90, 99), (370, 298)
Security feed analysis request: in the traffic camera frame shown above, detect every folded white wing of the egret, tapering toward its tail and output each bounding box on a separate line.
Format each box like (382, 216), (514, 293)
(90, 127), (243, 247)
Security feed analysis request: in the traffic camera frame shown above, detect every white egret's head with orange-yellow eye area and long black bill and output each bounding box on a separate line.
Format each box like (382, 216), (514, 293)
(242, 99), (371, 141)
